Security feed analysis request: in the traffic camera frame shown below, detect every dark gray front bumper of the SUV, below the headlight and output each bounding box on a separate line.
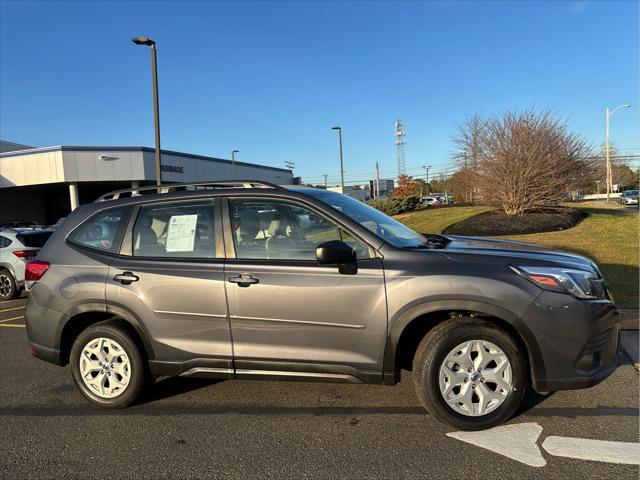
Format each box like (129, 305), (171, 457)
(524, 291), (620, 392)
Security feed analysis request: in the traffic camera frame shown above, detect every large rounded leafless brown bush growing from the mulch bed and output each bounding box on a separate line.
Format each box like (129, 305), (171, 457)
(456, 110), (591, 215)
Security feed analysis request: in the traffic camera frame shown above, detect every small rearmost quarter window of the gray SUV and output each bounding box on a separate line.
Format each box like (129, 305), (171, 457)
(69, 207), (131, 253)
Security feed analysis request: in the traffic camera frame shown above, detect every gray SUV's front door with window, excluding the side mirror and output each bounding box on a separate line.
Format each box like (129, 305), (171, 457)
(223, 197), (387, 382)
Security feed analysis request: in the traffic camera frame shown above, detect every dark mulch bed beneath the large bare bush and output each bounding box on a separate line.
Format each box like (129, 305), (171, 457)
(443, 207), (587, 236)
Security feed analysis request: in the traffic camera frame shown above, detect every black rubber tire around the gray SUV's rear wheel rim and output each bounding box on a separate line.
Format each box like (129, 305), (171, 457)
(69, 320), (148, 408)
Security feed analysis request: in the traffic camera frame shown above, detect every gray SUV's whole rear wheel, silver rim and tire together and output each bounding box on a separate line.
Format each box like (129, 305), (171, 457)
(69, 321), (145, 408)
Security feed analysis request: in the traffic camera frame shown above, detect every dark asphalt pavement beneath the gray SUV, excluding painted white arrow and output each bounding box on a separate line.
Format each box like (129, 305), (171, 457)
(0, 300), (639, 480)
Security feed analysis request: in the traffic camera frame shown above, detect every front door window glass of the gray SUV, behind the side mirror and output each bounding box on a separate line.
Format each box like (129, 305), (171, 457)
(230, 199), (369, 261)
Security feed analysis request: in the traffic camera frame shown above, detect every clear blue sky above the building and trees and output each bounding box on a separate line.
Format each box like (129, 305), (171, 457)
(0, 0), (640, 184)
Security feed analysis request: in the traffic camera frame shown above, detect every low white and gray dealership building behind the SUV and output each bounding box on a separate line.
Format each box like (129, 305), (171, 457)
(0, 141), (296, 224)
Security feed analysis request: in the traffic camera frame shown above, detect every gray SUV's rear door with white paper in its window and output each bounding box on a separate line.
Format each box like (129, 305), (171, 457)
(106, 199), (233, 377)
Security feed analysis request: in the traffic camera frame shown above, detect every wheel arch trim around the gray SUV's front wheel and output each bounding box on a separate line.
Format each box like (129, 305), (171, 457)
(384, 300), (544, 384)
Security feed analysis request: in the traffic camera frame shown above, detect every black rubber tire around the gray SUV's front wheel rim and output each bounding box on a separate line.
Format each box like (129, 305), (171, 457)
(413, 317), (528, 430)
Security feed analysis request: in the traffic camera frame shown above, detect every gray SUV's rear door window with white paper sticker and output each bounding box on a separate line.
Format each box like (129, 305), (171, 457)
(133, 201), (216, 258)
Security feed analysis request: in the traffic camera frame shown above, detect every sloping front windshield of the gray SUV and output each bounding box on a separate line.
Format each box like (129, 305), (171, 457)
(305, 189), (426, 248)
